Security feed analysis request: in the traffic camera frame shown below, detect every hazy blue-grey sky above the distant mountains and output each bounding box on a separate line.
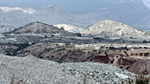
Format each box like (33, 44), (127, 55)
(0, 0), (150, 13)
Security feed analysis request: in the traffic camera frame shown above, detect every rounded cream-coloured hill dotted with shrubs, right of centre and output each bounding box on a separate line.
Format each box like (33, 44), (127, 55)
(81, 20), (143, 38)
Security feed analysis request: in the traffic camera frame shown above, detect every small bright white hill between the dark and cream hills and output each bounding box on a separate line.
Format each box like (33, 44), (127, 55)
(54, 24), (84, 33)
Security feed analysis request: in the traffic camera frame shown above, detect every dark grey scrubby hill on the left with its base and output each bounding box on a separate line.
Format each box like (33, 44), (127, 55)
(4, 22), (77, 44)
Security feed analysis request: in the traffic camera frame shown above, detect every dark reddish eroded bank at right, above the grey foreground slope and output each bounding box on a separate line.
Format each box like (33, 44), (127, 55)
(118, 57), (150, 75)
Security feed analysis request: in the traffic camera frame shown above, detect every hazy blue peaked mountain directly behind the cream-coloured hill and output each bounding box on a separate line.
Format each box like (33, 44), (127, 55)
(74, 0), (150, 30)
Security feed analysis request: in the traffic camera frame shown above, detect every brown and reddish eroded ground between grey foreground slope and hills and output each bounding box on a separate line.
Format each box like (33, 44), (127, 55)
(0, 43), (150, 74)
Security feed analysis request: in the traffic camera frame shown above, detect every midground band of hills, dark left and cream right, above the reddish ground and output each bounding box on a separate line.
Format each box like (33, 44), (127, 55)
(0, 20), (149, 44)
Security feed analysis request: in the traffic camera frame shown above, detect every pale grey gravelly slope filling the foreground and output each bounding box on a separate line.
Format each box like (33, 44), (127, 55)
(0, 55), (134, 84)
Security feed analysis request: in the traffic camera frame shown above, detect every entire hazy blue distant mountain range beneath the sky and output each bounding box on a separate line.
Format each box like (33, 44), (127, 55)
(0, 0), (150, 30)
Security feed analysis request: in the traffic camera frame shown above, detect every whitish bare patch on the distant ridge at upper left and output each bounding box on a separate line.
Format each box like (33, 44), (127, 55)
(0, 6), (35, 14)
